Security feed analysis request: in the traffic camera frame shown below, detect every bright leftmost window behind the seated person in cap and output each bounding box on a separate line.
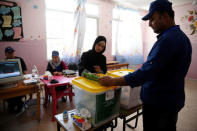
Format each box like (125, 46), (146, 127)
(46, 0), (75, 59)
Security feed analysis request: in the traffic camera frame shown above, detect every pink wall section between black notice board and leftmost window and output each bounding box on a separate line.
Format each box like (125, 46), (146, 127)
(0, 0), (47, 73)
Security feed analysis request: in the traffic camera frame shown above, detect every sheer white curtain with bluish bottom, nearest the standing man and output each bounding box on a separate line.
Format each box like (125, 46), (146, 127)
(112, 6), (143, 65)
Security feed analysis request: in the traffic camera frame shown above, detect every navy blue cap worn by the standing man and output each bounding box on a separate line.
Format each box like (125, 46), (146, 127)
(142, 0), (172, 20)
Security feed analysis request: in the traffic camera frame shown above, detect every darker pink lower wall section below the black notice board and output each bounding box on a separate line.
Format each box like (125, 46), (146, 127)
(0, 40), (47, 74)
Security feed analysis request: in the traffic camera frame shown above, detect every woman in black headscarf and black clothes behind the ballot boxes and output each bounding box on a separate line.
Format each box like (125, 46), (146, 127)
(79, 36), (107, 75)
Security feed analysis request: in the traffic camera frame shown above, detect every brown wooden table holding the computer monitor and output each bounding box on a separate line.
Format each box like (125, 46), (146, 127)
(0, 82), (40, 120)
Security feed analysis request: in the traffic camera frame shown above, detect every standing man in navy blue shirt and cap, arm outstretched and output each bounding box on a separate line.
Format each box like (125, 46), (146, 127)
(100, 0), (192, 131)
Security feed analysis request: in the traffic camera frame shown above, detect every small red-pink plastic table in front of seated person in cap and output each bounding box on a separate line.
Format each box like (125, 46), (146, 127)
(41, 76), (76, 121)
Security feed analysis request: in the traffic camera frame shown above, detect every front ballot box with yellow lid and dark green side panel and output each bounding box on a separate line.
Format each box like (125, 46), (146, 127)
(72, 77), (121, 126)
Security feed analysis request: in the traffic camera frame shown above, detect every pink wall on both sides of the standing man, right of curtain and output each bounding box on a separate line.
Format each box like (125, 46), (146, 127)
(143, 3), (197, 79)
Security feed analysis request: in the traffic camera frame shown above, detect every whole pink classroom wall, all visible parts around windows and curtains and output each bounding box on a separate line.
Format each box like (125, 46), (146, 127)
(0, 0), (197, 79)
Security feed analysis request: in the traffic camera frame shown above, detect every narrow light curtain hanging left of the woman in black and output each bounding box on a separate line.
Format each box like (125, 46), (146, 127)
(63, 0), (86, 63)
